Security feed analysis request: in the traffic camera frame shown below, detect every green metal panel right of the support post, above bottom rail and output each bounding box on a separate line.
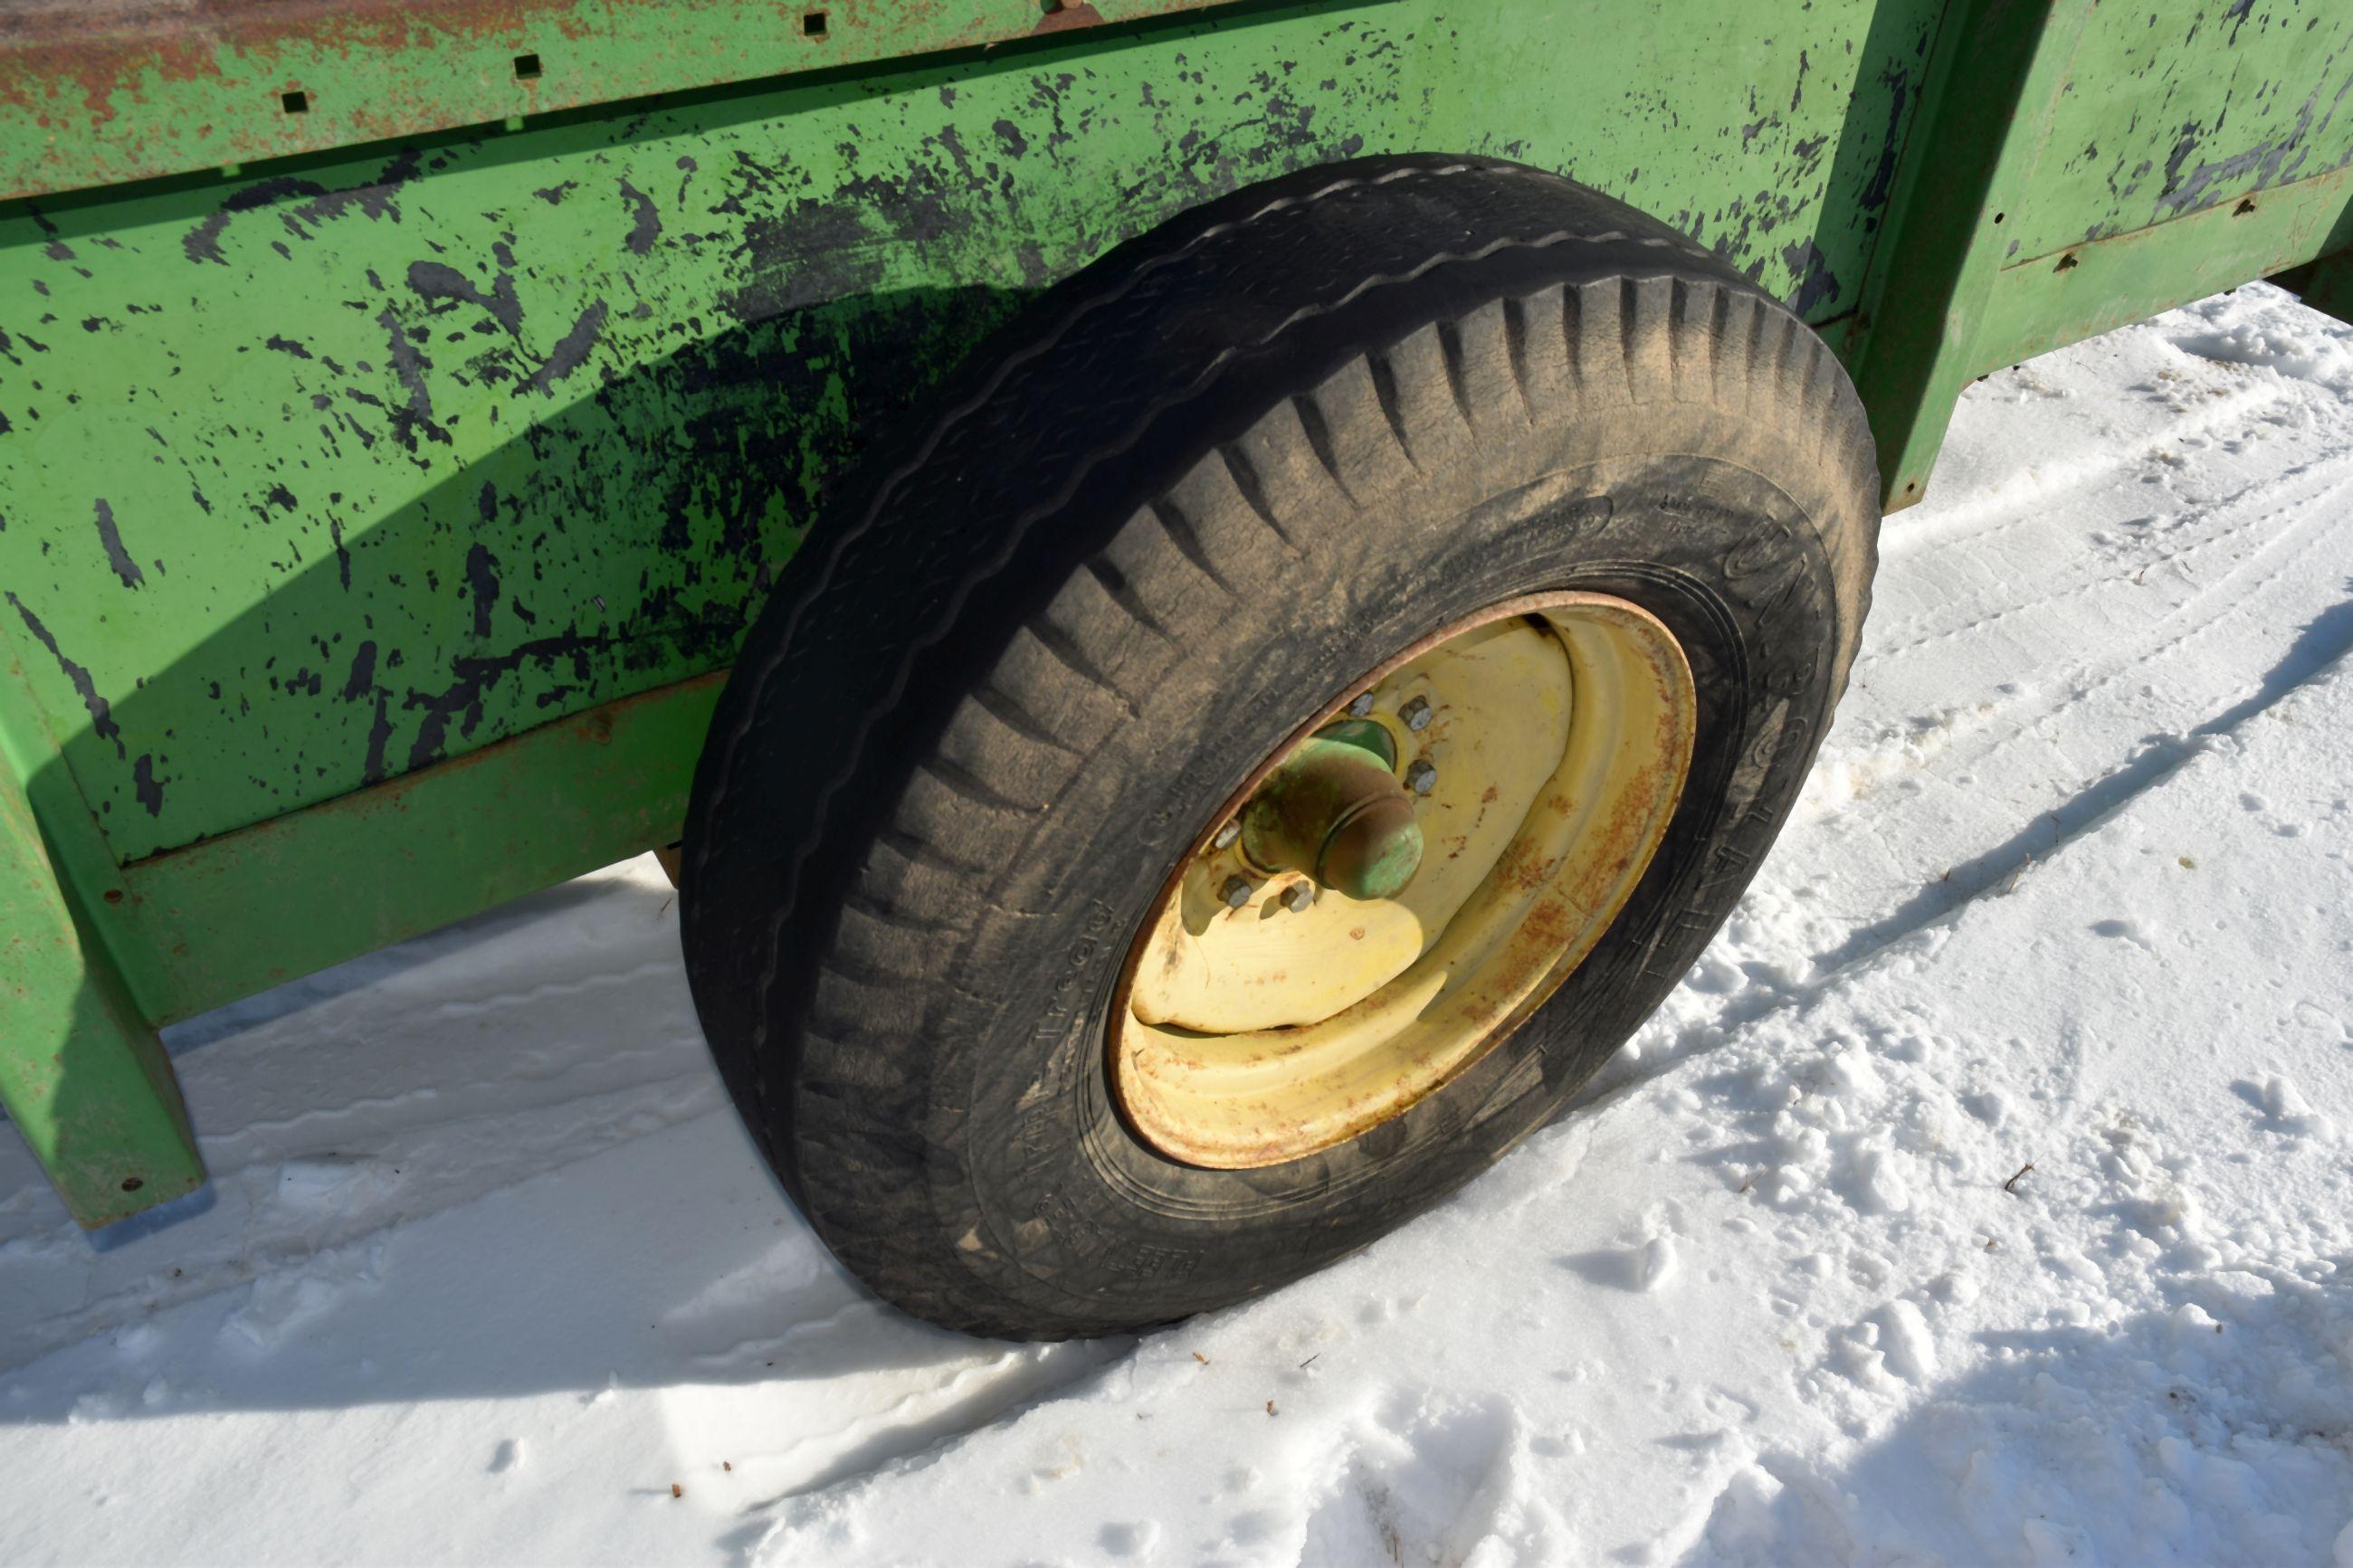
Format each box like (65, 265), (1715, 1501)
(2005, 0), (2353, 259)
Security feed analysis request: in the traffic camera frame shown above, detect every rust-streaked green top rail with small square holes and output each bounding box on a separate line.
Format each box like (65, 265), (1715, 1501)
(0, 0), (1242, 197)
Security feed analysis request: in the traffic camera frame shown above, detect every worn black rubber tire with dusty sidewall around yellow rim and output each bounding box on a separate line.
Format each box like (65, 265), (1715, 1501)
(682, 155), (1878, 1337)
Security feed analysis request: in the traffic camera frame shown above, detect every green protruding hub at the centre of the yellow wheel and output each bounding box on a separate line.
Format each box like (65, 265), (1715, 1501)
(1243, 719), (1421, 898)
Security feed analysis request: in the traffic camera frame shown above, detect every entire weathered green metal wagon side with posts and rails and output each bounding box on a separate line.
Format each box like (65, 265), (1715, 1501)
(0, 0), (2353, 1225)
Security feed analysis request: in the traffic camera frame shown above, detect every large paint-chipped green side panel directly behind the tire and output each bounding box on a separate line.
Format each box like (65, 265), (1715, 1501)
(0, 5), (1927, 879)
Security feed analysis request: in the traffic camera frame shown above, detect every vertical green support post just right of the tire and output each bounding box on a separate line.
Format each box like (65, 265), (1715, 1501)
(1850, 0), (2094, 512)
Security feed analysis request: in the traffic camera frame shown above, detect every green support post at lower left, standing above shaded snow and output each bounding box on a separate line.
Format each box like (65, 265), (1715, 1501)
(0, 640), (205, 1227)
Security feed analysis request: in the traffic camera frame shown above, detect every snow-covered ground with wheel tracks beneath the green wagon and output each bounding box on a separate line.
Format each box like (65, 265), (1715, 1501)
(0, 287), (2353, 1568)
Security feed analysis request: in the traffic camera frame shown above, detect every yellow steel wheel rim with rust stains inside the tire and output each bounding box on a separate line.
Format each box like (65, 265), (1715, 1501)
(1110, 593), (1697, 1171)
